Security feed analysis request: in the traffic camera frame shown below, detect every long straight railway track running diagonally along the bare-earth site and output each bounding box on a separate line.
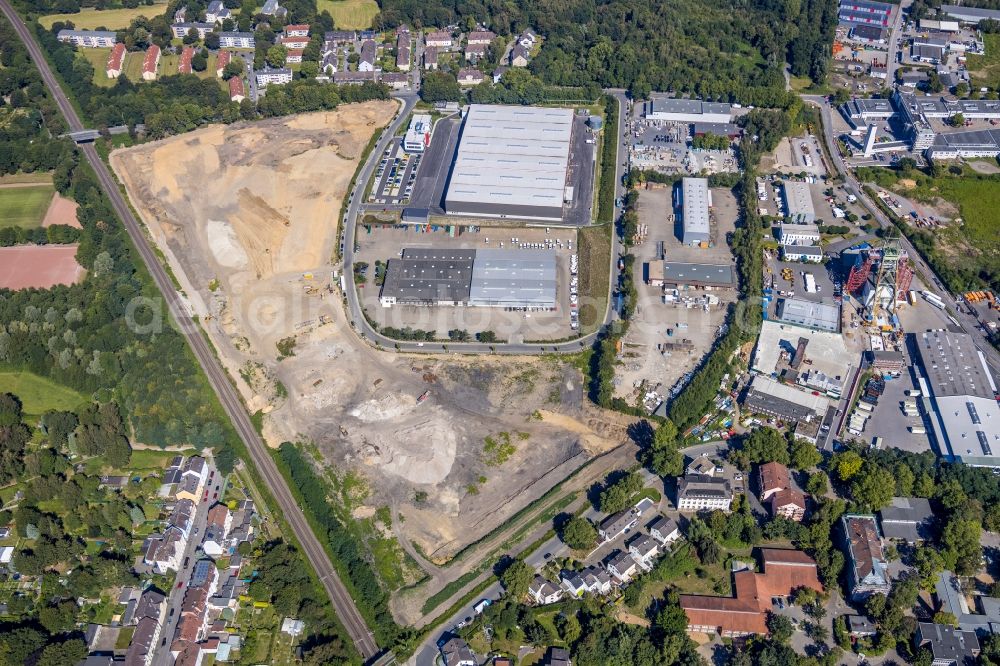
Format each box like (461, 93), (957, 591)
(0, 0), (379, 659)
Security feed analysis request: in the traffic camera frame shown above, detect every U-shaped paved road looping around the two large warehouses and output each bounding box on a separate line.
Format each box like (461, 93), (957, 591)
(344, 90), (627, 354)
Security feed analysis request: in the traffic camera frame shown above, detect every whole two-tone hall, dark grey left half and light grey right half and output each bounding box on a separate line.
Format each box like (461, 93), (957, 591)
(379, 249), (556, 309)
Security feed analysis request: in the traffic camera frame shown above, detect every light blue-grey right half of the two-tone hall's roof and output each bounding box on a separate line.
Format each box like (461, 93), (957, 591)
(469, 250), (556, 307)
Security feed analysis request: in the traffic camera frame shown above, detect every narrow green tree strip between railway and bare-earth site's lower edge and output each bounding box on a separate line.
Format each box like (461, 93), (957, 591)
(278, 442), (408, 645)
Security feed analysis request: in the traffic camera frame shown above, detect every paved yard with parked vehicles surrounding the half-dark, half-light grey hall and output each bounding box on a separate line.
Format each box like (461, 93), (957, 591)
(355, 225), (578, 342)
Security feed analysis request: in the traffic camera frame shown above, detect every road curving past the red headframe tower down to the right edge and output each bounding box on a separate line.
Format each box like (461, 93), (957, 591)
(802, 95), (1000, 370)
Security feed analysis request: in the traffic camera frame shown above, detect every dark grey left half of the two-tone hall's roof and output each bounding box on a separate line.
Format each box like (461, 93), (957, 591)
(382, 249), (476, 303)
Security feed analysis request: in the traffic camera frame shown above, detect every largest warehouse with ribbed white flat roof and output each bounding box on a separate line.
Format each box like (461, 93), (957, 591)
(444, 104), (573, 221)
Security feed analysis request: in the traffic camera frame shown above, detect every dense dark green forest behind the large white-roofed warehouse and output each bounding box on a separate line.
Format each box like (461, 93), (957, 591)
(381, 0), (836, 96)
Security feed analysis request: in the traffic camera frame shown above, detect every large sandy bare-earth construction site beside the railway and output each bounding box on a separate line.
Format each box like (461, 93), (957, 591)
(110, 102), (635, 626)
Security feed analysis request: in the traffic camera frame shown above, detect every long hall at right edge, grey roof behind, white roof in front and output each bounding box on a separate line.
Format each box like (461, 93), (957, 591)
(914, 330), (1000, 467)
